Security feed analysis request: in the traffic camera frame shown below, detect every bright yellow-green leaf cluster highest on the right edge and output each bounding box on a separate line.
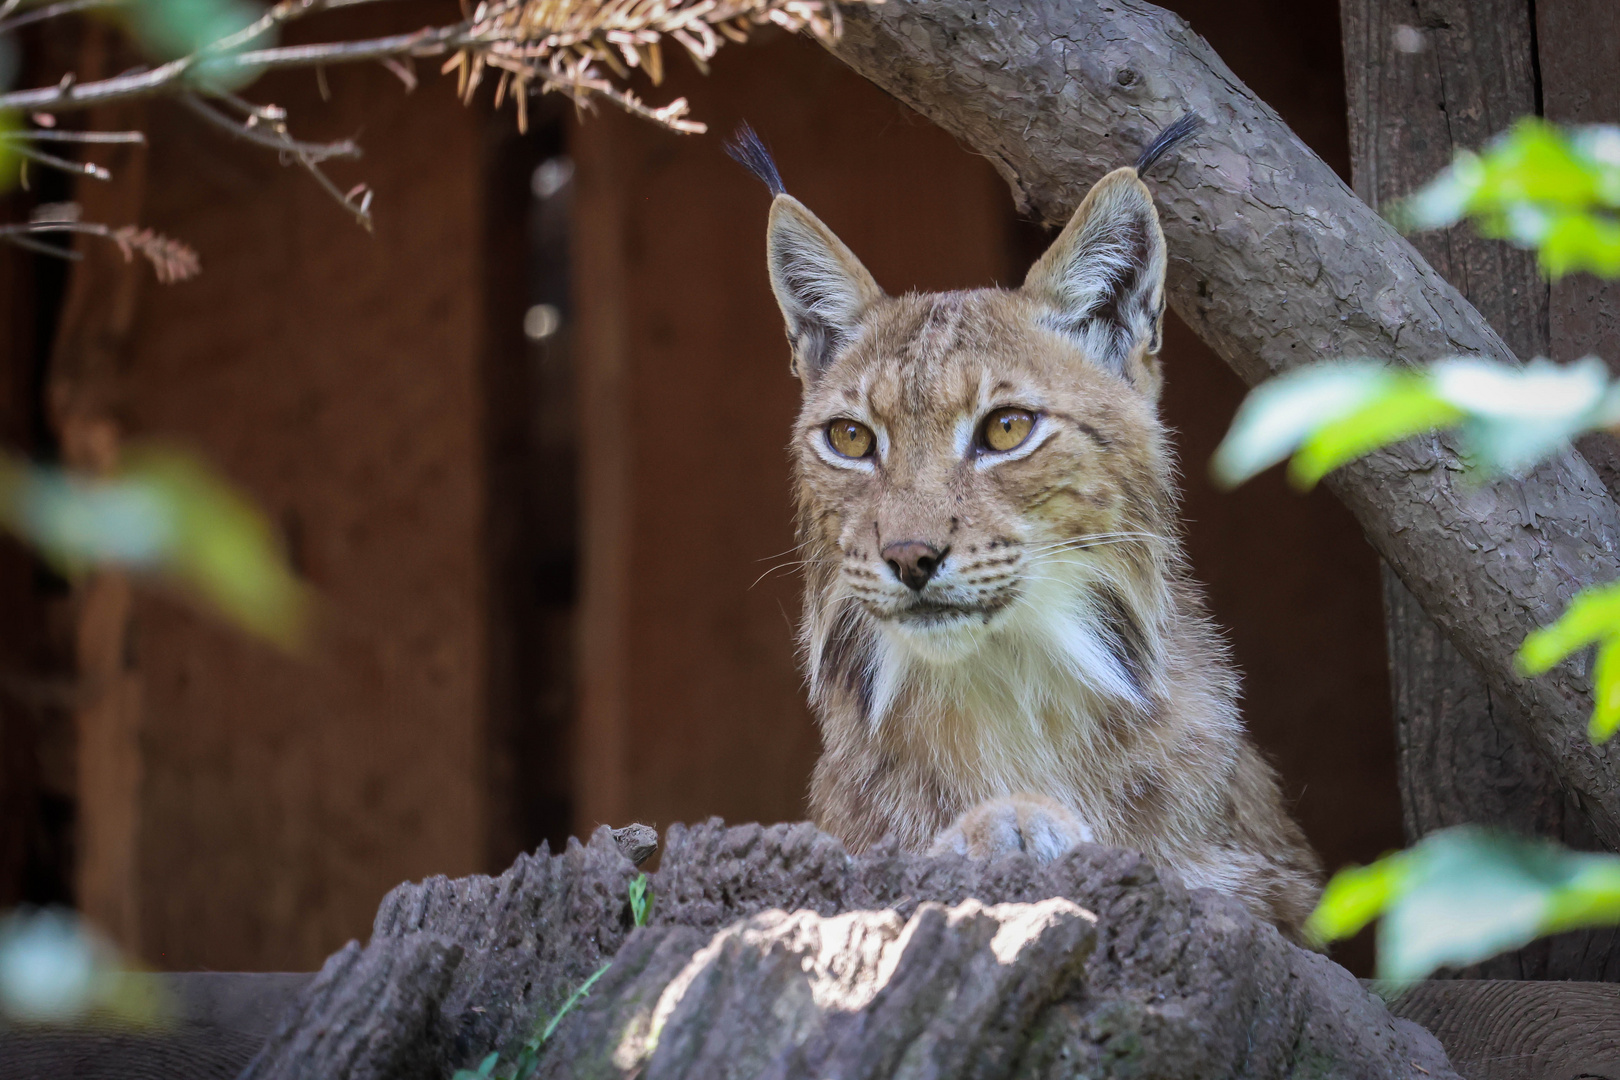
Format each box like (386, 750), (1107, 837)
(1390, 117), (1620, 277)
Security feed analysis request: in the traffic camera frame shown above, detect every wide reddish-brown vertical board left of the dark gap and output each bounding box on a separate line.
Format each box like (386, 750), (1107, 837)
(93, 8), (484, 970)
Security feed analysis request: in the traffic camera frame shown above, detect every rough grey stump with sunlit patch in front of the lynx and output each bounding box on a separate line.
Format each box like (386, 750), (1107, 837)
(243, 821), (1456, 1080)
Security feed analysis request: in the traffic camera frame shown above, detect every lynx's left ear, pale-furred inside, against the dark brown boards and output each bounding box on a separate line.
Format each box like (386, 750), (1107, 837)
(765, 194), (883, 384)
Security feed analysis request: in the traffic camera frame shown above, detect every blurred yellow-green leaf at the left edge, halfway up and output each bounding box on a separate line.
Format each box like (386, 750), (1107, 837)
(0, 447), (308, 648)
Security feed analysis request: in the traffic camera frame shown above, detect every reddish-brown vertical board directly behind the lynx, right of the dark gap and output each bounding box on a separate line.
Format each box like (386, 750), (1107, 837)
(575, 36), (1009, 832)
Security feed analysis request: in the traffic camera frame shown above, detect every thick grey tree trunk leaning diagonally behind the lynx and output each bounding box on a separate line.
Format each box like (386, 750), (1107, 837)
(822, 0), (1620, 847)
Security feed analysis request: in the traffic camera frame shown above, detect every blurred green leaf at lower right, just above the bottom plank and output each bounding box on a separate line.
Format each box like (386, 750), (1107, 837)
(1309, 826), (1620, 983)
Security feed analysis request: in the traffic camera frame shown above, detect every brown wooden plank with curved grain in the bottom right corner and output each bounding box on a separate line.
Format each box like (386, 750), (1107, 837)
(1390, 980), (1620, 1080)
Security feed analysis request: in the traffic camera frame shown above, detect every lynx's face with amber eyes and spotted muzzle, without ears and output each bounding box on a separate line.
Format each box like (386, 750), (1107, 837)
(795, 290), (1166, 662)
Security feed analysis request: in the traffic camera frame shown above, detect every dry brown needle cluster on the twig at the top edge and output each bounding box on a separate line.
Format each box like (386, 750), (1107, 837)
(444, 0), (883, 133)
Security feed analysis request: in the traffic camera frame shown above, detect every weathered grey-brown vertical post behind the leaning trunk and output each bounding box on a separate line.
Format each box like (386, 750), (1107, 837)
(1340, 0), (1620, 980)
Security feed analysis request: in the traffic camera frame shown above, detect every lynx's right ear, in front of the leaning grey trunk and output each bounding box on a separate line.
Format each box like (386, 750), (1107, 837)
(1024, 168), (1166, 397)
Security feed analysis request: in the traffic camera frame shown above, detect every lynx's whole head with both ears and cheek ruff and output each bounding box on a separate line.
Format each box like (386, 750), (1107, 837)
(741, 124), (1198, 721)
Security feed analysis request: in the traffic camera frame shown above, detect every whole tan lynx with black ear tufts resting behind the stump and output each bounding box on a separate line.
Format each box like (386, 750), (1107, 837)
(732, 123), (1320, 938)
